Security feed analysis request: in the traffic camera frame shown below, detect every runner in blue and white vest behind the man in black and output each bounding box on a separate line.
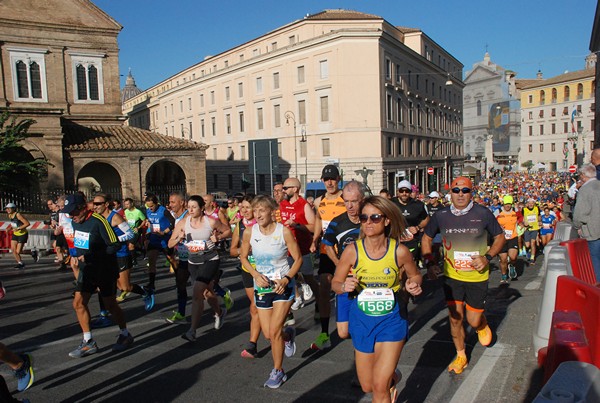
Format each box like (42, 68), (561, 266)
(94, 193), (154, 314)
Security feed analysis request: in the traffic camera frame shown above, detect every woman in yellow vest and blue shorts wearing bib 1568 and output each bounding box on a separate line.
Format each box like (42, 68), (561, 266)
(332, 196), (423, 402)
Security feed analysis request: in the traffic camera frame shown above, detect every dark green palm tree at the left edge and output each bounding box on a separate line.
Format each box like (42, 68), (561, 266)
(0, 110), (51, 188)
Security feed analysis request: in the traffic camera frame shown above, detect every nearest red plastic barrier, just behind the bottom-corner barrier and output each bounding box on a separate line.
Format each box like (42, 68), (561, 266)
(544, 311), (593, 383)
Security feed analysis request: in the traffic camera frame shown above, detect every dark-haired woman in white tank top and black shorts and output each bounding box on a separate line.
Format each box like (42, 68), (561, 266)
(169, 195), (231, 342)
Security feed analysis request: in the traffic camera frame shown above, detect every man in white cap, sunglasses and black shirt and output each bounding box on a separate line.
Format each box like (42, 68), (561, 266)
(392, 180), (429, 265)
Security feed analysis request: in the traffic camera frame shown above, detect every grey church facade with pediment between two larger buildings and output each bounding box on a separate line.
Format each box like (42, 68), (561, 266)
(463, 52), (521, 176)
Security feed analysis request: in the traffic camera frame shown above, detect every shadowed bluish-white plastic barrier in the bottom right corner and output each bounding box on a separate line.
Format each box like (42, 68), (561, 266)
(533, 361), (600, 403)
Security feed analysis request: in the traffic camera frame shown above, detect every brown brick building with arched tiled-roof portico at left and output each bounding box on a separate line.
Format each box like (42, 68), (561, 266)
(0, 0), (206, 208)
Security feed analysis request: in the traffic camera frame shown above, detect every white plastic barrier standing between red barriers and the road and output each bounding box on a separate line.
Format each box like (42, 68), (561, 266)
(533, 245), (571, 357)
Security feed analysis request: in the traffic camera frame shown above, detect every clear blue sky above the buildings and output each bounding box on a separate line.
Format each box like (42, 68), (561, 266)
(92, 0), (597, 90)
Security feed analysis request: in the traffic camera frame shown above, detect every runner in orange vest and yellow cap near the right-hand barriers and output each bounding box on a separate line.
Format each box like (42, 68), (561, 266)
(496, 195), (519, 284)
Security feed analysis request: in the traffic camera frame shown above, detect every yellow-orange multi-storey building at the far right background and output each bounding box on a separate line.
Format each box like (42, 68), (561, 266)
(519, 64), (596, 172)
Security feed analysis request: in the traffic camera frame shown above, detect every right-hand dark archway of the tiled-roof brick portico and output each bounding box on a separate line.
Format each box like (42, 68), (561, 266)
(146, 160), (187, 205)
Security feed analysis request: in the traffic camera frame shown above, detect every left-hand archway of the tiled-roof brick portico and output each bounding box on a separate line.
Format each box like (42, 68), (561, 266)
(77, 162), (123, 199)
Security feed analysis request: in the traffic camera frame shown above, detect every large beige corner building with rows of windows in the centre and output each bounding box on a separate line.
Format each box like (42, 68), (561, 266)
(123, 10), (463, 193)
